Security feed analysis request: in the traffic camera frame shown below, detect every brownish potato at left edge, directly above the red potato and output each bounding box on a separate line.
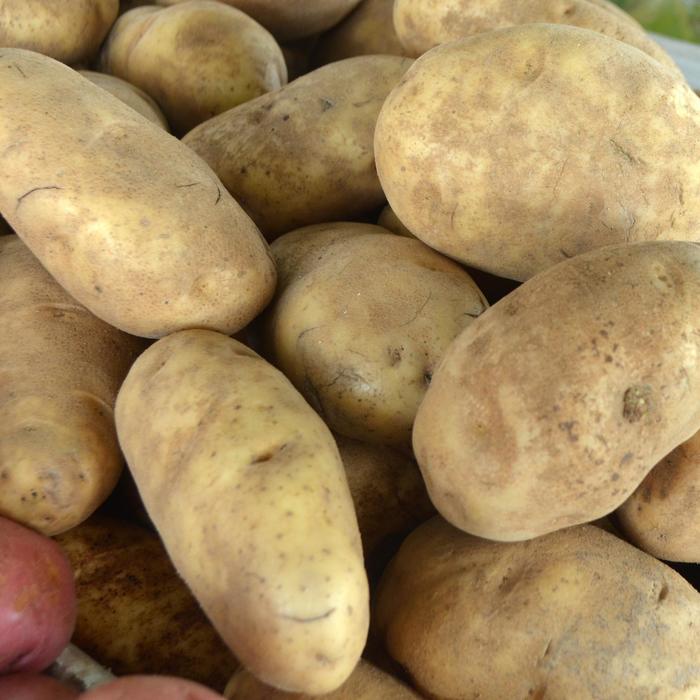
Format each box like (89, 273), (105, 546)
(0, 236), (143, 535)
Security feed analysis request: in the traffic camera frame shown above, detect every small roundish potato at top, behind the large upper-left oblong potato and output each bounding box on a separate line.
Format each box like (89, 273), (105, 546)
(102, 0), (287, 134)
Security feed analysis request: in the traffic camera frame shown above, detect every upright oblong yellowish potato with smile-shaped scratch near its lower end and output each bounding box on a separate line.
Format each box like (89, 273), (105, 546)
(116, 330), (369, 694)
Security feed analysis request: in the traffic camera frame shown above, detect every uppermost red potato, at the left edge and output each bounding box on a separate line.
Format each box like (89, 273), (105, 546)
(0, 518), (77, 676)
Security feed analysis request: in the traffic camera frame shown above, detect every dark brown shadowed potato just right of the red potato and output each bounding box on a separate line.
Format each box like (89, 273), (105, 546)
(52, 517), (237, 690)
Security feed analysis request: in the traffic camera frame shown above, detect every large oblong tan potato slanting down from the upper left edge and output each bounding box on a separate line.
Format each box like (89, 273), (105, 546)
(0, 49), (275, 337)
